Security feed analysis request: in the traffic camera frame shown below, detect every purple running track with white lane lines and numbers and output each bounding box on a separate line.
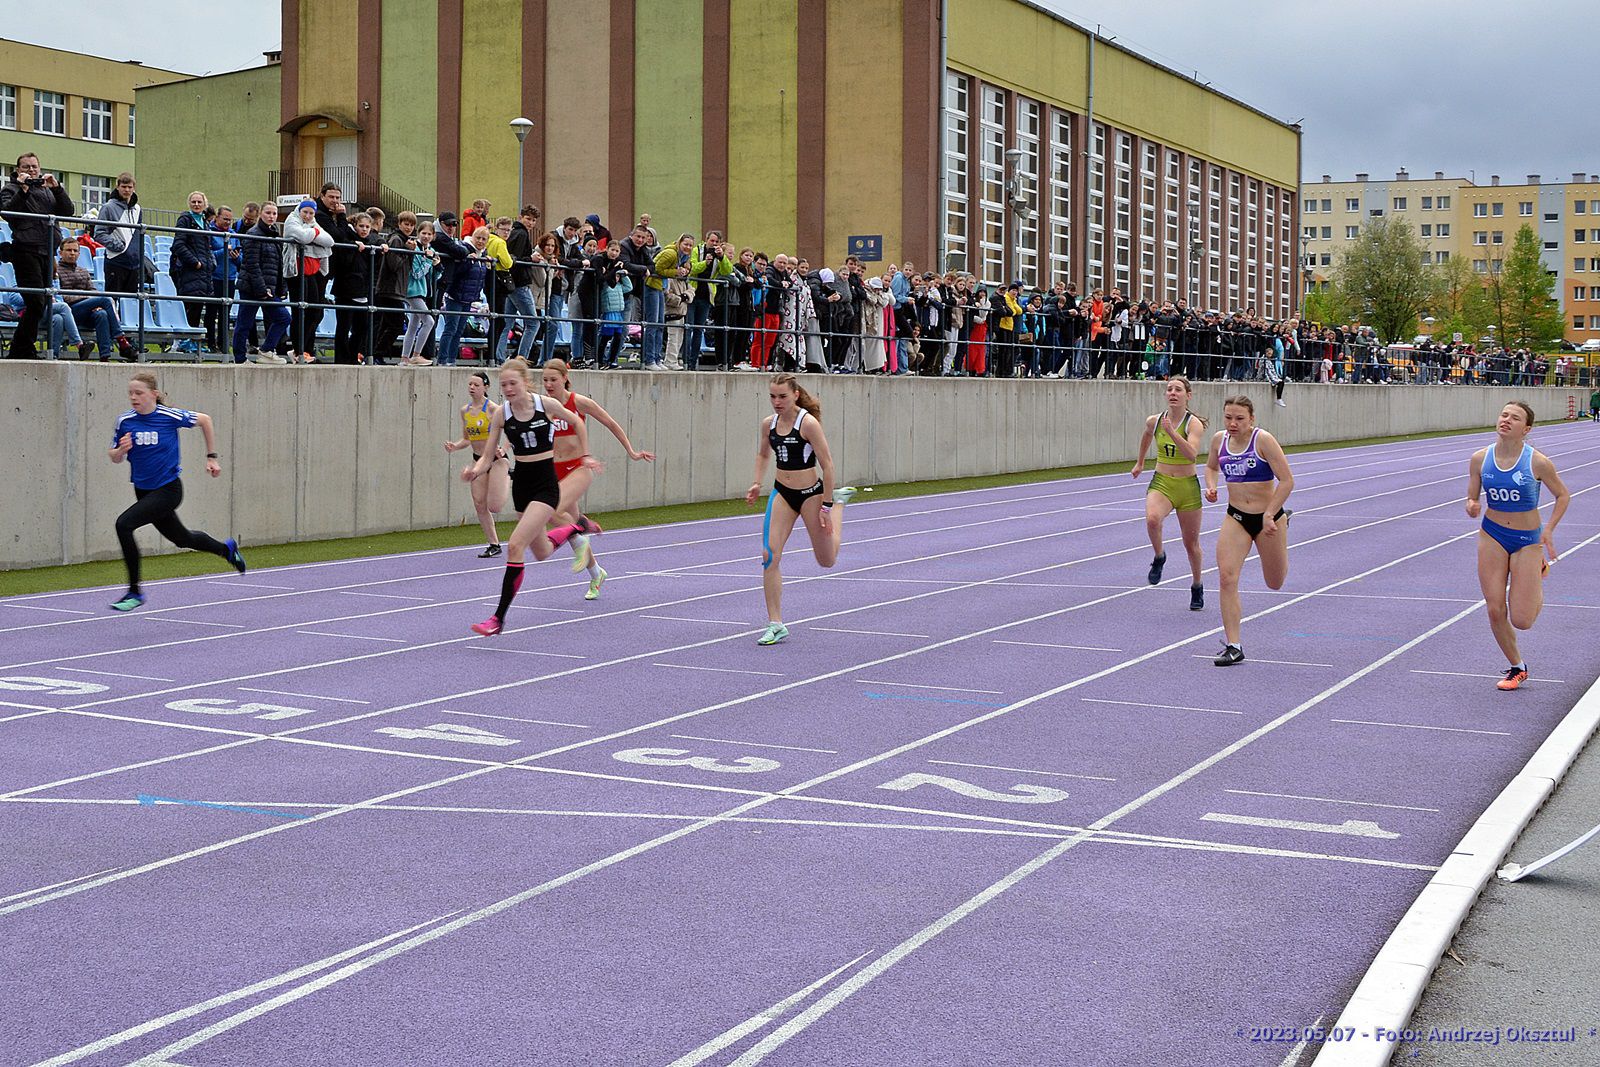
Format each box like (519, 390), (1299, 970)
(0, 424), (1600, 1067)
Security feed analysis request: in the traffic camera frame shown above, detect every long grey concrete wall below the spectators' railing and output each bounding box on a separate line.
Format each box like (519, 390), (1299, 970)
(0, 362), (1587, 569)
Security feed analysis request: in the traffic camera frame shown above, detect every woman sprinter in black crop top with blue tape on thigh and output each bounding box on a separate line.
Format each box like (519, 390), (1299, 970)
(744, 374), (856, 645)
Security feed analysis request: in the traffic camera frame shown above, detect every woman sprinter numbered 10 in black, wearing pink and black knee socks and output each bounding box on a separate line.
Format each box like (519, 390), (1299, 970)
(461, 358), (603, 637)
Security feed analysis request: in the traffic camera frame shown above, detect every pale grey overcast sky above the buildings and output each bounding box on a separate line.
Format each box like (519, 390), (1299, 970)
(0, 0), (1600, 184)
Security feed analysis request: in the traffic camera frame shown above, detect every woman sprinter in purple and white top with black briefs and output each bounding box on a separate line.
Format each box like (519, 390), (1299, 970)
(1205, 397), (1294, 667)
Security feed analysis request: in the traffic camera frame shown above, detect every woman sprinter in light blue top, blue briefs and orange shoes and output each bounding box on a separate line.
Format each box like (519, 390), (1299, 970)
(1467, 400), (1573, 689)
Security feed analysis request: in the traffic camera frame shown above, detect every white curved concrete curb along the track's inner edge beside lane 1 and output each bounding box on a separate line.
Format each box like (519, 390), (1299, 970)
(1315, 671), (1600, 1067)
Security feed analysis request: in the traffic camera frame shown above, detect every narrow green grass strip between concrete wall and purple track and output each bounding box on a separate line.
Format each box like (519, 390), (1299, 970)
(0, 419), (1467, 597)
